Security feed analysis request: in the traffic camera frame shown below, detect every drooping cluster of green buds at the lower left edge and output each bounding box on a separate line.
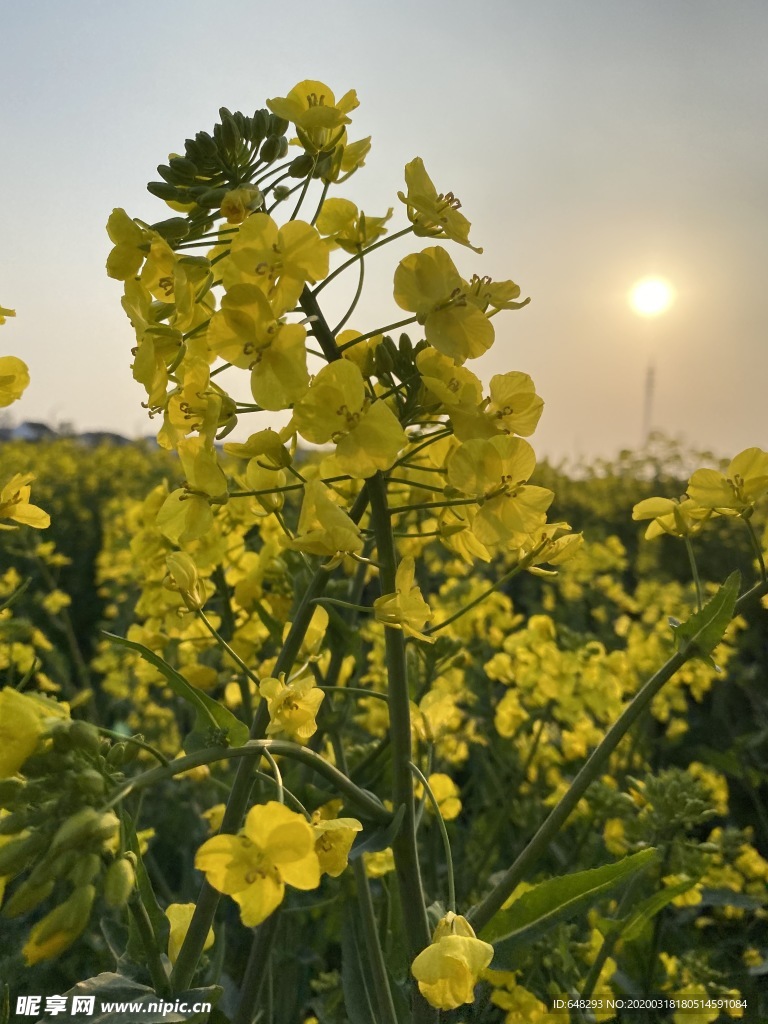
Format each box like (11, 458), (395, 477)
(0, 719), (137, 963)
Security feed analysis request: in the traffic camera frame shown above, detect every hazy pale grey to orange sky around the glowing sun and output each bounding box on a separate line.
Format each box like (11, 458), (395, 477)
(0, 0), (768, 457)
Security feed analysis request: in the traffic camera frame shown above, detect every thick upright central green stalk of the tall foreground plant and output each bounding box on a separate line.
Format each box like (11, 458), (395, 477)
(367, 473), (437, 1024)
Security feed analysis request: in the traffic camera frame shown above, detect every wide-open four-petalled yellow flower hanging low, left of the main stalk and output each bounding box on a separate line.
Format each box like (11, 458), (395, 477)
(195, 801), (321, 928)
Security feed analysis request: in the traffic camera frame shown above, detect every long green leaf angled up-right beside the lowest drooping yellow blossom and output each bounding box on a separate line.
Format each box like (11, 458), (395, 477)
(480, 849), (657, 970)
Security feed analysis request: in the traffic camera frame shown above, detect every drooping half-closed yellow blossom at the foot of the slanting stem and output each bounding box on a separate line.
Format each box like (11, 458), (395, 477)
(411, 912), (494, 1010)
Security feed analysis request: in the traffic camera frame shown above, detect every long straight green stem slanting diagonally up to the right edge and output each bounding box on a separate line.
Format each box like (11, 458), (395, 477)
(468, 581), (768, 931)
